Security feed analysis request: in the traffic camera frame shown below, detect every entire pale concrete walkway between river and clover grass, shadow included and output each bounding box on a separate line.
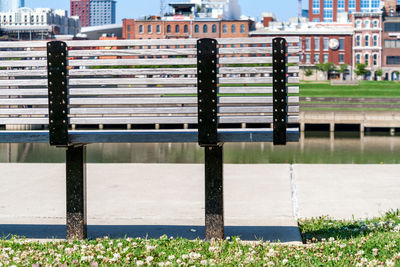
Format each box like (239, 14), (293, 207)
(0, 164), (400, 242)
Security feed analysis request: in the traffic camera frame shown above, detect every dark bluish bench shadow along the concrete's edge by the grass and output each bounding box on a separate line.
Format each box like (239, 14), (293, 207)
(0, 224), (301, 242)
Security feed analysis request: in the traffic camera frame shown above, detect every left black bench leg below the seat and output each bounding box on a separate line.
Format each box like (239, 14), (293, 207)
(66, 145), (87, 239)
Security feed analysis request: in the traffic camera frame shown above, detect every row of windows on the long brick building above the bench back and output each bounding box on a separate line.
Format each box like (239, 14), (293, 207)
(134, 24), (246, 34)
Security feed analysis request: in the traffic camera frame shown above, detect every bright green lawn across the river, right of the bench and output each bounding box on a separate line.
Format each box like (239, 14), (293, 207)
(300, 81), (400, 98)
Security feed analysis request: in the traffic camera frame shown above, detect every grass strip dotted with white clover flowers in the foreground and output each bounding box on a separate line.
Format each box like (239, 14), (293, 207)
(0, 211), (400, 266)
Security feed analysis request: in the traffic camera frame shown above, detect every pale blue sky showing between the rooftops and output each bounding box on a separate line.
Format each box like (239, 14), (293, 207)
(25, 0), (308, 23)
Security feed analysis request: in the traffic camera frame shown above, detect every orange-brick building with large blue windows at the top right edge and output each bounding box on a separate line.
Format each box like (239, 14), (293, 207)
(308, 0), (384, 22)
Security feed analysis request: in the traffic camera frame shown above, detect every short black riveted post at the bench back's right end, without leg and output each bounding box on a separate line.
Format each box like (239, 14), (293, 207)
(272, 38), (287, 145)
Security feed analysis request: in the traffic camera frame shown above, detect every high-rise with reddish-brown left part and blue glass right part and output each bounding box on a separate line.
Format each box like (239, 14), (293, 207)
(70, 0), (116, 27)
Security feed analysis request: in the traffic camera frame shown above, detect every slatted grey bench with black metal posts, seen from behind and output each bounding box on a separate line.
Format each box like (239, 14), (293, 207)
(0, 37), (299, 239)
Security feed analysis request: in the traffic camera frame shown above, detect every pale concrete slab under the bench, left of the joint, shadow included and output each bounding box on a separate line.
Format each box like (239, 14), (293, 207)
(0, 164), (301, 242)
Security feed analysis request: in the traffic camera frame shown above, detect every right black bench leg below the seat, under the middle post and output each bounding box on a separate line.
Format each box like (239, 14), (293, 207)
(205, 146), (224, 240)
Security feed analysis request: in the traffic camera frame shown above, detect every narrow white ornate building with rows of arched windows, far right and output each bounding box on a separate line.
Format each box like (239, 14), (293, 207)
(352, 12), (382, 80)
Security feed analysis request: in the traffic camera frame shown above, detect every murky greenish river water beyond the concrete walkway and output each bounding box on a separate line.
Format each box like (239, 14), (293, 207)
(0, 132), (400, 164)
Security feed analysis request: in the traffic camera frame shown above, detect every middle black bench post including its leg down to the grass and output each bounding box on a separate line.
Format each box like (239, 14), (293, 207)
(197, 38), (224, 240)
